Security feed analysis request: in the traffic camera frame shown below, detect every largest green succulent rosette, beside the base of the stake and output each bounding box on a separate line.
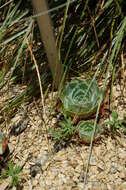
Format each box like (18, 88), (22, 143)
(60, 79), (101, 118)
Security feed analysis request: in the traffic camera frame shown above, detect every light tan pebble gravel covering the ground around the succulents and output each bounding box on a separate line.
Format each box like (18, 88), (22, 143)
(1, 83), (126, 190)
